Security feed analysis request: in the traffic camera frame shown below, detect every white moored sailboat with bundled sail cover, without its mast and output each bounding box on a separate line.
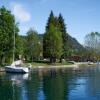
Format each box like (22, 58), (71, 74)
(5, 60), (31, 73)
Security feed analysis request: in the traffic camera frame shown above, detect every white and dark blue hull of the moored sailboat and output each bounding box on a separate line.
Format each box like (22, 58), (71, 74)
(5, 66), (29, 73)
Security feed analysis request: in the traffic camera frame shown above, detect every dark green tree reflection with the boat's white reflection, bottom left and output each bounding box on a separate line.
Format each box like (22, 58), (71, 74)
(0, 74), (28, 100)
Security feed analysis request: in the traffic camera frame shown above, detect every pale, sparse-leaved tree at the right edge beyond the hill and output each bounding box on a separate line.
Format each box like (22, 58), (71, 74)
(85, 32), (100, 59)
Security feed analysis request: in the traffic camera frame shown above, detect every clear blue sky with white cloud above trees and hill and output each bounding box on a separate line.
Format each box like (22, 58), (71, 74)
(0, 0), (100, 44)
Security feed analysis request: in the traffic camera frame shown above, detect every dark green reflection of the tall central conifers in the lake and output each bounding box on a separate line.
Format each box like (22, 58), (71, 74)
(43, 70), (68, 100)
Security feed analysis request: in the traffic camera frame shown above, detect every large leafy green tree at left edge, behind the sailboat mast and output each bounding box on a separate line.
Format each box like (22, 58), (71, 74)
(0, 6), (18, 64)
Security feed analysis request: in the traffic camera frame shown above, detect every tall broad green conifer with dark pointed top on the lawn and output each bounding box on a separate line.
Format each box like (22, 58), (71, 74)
(43, 11), (62, 63)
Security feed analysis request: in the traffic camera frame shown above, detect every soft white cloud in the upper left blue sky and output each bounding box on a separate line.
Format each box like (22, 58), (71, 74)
(11, 3), (31, 22)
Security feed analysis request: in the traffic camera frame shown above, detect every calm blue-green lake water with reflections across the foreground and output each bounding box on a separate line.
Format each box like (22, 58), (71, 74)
(0, 66), (100, 100)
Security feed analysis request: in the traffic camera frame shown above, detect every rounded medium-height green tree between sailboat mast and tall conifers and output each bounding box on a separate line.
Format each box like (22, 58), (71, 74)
(26, 29), (41, 61)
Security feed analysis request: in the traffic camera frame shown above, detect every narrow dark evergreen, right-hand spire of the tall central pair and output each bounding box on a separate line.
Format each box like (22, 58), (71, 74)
(58, 14), (68, 58)
